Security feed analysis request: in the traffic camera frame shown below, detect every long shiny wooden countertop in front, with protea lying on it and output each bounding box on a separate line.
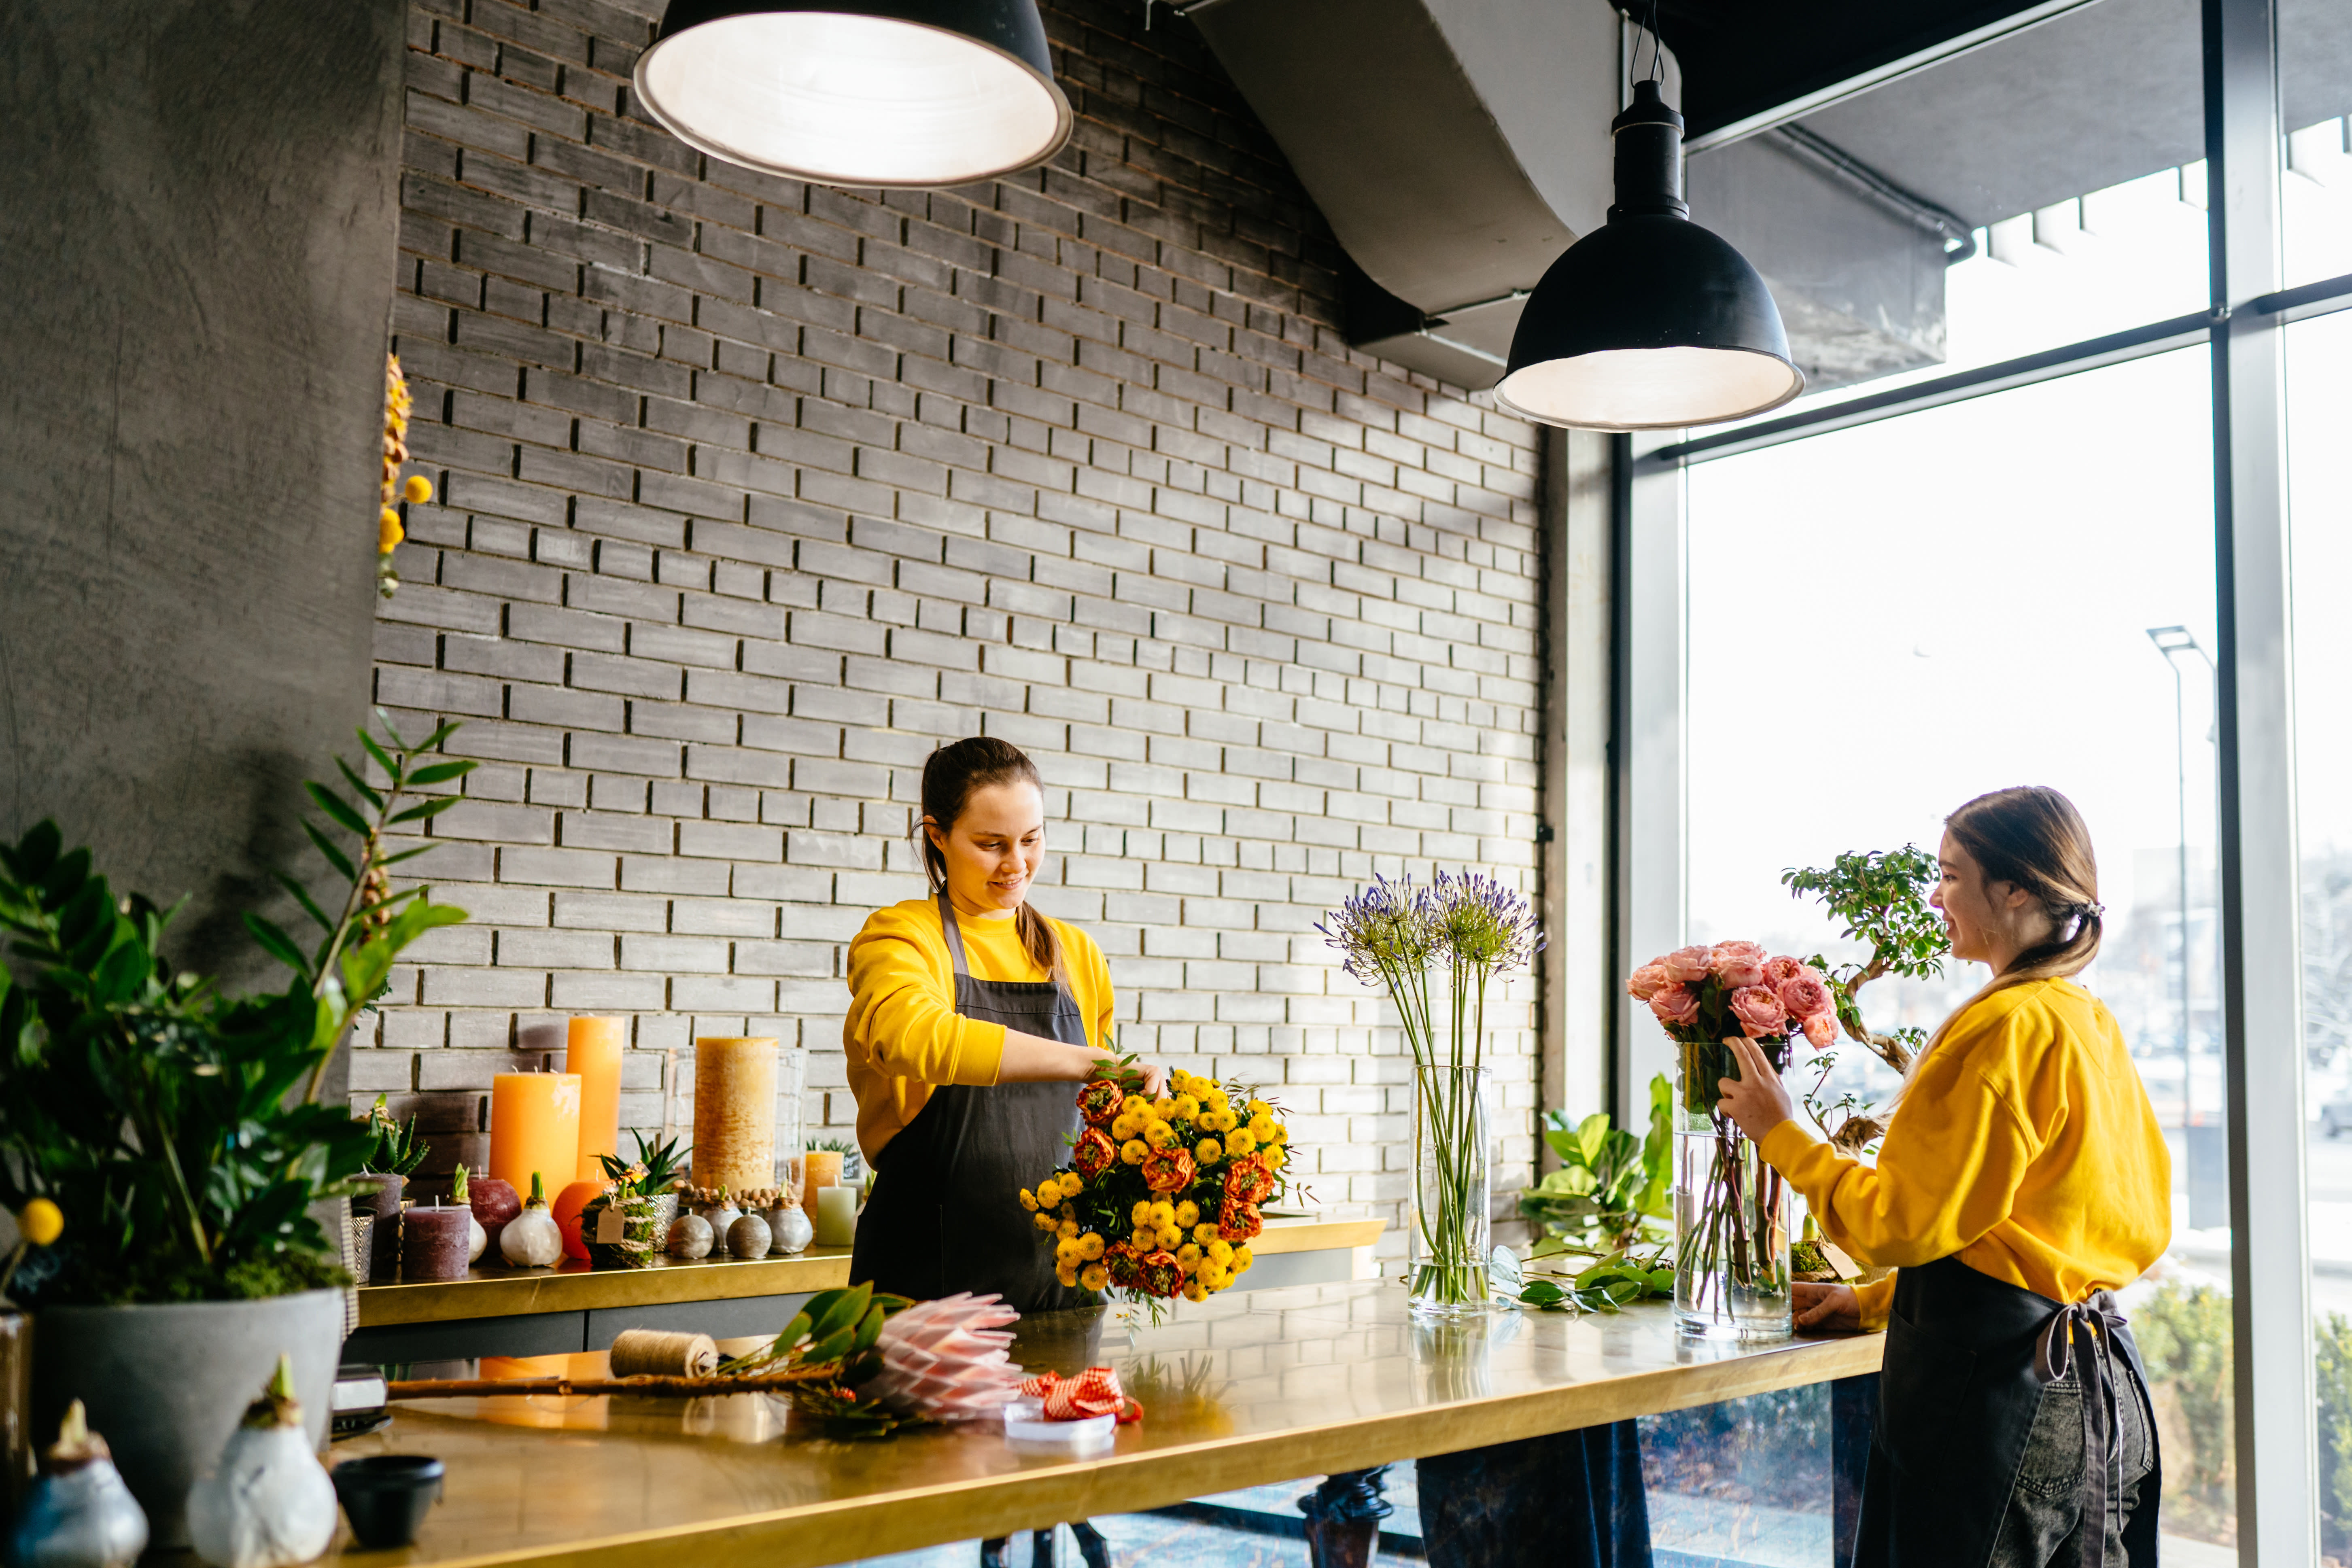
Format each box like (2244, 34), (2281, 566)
(334, 1281), (1882, 1568)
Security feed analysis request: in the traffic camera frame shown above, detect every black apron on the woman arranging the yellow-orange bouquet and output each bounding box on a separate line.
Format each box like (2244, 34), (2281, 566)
(849, 891), (1094, 1312)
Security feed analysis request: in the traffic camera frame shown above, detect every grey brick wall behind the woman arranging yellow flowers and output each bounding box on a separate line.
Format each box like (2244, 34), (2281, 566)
(350, 0), (1541, 1251)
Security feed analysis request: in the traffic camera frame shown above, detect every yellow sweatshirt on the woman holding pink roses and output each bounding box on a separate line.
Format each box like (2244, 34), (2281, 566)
(1759, 980), (2173, 1328)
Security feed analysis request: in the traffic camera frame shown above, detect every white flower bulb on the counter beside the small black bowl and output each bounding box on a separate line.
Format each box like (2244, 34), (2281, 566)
(188, 1354), (334, 1568)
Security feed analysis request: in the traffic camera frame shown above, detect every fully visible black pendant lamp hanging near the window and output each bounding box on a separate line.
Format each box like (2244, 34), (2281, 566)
(1494, 82), (1804, 430)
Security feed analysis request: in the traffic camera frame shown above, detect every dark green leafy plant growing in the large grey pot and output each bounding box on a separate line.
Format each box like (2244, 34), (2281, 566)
(0, 715), (473, 1305)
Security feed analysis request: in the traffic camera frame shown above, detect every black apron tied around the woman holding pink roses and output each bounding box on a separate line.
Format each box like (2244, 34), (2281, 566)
(1853, 1258), (2164, 1568)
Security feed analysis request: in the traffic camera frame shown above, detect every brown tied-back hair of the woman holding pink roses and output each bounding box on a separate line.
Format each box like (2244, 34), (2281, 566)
(1912, 785), (2105, 1067)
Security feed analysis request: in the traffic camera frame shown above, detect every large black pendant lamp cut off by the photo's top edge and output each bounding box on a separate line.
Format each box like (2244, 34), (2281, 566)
(637, 0), (1070, 186)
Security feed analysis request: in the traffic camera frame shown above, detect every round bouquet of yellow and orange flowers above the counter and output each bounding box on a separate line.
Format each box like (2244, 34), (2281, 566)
(1021, 1063), (1291, 1303)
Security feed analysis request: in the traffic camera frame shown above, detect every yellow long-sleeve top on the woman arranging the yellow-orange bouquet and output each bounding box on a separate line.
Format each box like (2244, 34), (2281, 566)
(842, 898), (1110, 1159)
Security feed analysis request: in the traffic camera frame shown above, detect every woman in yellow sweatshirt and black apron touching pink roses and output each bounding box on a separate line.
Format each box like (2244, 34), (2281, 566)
(1722, 787), (2171, 1568)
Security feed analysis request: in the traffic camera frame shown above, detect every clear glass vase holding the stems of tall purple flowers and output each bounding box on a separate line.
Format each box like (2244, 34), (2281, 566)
(1407, 1067), (1494, 1314)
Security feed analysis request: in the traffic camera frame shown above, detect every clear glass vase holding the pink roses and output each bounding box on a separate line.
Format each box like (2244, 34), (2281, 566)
(1675, 1044), (1795, 1340)
